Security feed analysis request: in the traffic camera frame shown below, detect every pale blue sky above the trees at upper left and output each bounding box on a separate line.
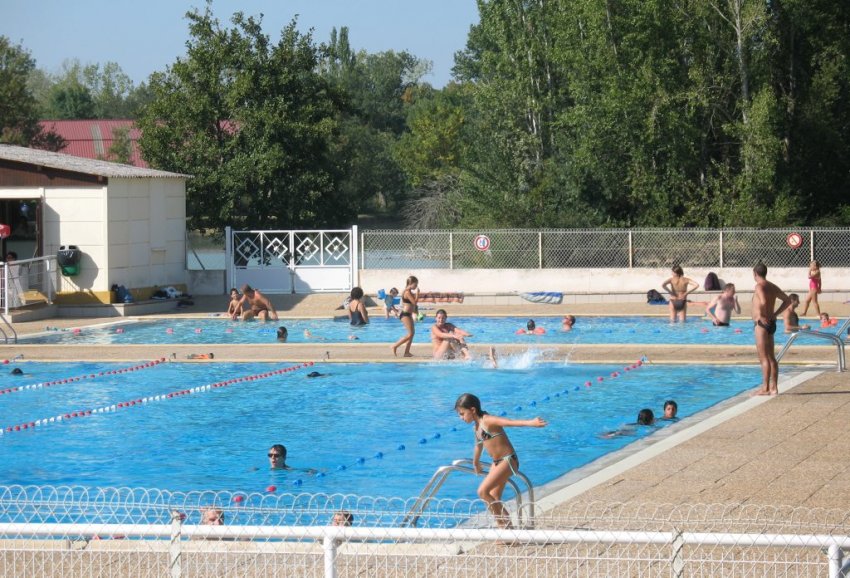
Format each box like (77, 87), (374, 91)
(0, 0), (478, 88)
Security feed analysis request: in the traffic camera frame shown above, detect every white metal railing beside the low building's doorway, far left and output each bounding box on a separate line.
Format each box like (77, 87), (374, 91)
(0, 255), (59, 315)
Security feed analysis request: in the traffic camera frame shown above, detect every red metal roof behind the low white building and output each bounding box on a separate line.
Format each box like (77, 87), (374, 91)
(40, 120), (149, 169)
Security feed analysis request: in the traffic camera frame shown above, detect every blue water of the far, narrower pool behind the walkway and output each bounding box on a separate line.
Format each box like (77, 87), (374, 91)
(21, 315), (823, 346)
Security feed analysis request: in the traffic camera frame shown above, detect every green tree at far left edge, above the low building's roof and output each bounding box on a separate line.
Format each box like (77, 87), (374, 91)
(0, 36), (65, 151)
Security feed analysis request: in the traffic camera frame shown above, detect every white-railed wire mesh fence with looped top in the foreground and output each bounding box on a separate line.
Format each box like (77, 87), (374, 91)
(0, 486), (850, 578)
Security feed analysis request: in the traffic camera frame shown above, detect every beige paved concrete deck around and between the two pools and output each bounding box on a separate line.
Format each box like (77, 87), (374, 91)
(0, 295), (850, 508)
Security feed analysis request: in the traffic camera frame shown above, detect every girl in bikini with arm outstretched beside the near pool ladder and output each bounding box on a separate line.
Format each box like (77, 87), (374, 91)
(455, 393), (547, 528)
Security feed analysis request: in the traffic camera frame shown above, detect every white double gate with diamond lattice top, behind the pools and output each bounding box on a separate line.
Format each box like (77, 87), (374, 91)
(226, 226), (358, 294)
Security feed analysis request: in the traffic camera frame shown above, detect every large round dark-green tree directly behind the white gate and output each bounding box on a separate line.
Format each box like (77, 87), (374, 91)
(137, 7), (342, 229)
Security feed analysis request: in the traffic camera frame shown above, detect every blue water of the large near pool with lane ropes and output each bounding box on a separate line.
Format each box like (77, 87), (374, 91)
(0, 355), (759, 499)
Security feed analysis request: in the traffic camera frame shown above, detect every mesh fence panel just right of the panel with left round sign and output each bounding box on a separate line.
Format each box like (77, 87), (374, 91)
(543, 229), (630, 269)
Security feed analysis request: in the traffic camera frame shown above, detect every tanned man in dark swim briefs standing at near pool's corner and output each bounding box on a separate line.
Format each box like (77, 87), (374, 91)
(753, 263), (791, 395)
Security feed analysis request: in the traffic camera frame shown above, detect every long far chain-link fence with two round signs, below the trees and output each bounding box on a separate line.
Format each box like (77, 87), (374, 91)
(360, 228), (850, 270)
